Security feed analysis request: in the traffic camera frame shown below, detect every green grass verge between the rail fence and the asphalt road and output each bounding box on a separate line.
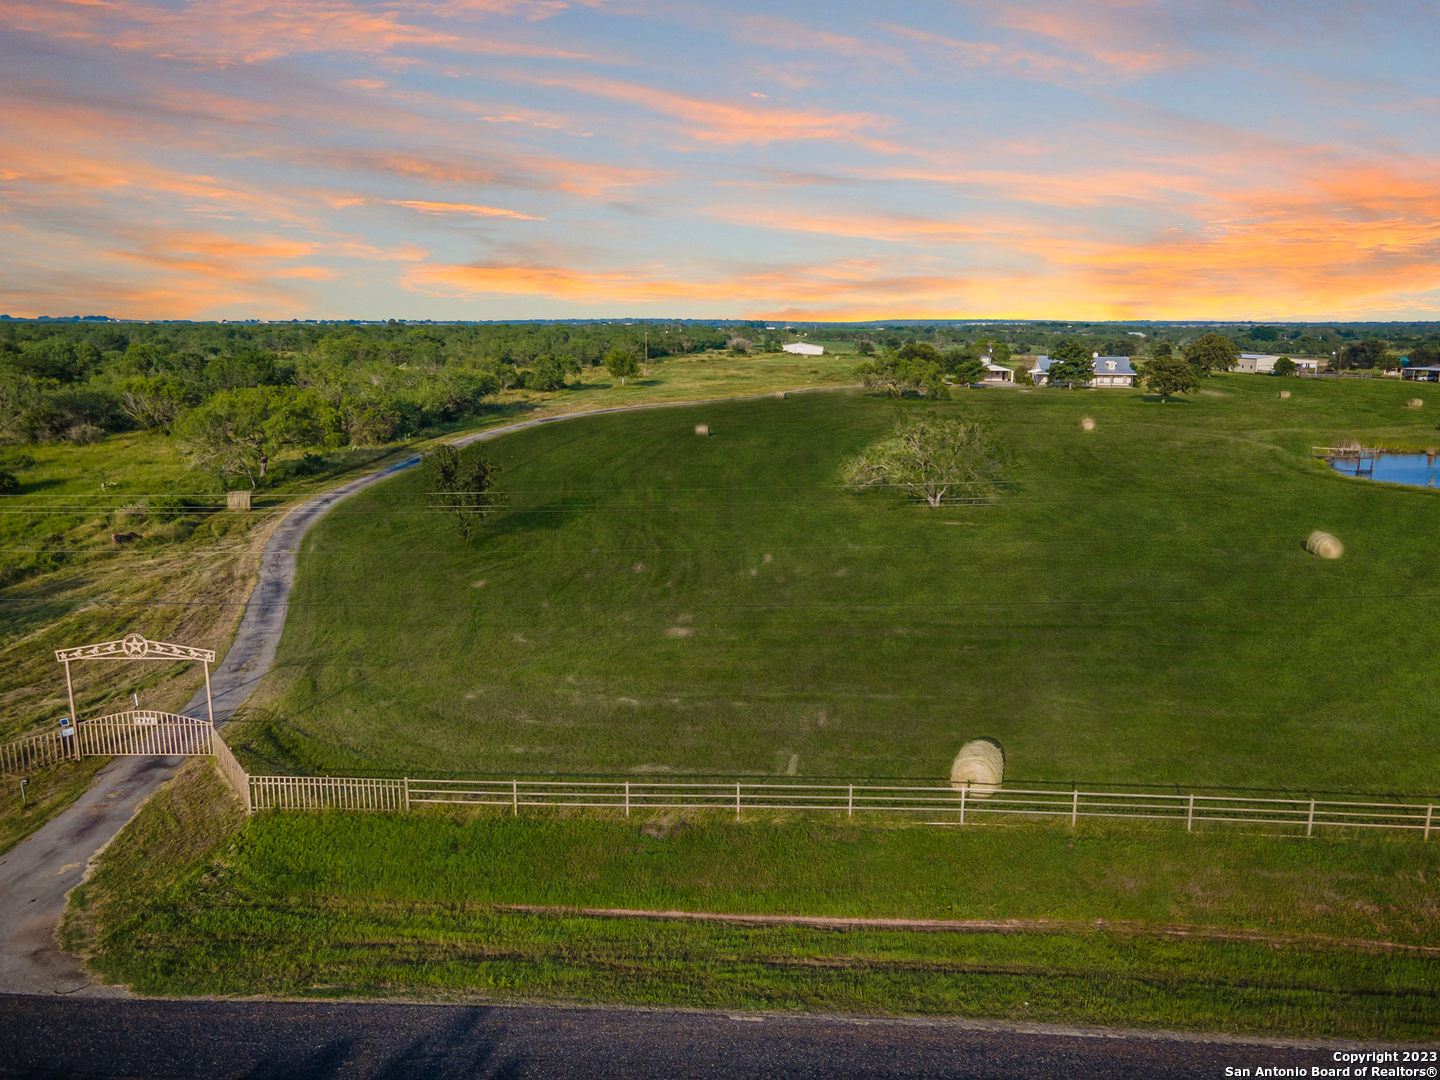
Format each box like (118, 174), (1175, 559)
(63, 762), (1440, 1040)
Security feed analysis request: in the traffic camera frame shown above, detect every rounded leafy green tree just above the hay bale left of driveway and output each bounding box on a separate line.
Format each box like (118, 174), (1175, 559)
(174, 386), (341, 488)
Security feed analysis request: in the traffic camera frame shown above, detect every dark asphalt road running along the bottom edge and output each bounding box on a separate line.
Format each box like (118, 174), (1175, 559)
(0, 995), (1434, 1080)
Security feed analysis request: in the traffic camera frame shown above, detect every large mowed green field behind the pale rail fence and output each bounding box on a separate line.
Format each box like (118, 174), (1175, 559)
(253, 374), (1440, 793)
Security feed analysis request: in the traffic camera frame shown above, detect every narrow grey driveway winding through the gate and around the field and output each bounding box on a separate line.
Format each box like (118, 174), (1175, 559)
(0, 387), (848, 996)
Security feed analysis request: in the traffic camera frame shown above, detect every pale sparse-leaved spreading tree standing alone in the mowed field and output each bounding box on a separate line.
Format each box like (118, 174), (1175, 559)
(842, 415), (1004, 508)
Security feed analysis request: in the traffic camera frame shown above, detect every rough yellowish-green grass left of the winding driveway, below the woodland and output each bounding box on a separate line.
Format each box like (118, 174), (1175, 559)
(0, 347), (852, 851)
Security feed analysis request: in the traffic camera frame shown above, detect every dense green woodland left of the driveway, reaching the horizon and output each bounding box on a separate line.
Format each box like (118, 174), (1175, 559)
(0, 321), (732, 487)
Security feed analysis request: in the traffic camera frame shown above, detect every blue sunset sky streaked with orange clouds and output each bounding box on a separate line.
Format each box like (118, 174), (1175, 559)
(0, 0), (1440, 320)
